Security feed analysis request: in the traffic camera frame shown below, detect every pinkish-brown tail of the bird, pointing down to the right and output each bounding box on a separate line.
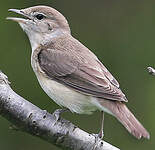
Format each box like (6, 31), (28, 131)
(100, 100), (150, 139)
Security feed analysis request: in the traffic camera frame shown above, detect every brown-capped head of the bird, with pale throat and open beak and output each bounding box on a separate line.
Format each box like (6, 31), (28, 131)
(7, 6), (70, 48)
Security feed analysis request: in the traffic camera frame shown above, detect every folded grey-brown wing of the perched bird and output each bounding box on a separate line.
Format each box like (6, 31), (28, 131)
(38, 44), (127, 101)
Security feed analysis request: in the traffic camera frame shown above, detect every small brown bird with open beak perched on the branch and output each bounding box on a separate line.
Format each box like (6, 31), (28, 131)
(8, 6), (150, 139)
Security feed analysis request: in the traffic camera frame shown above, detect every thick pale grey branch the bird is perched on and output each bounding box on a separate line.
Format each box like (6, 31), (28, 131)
(0, 72), (119, 150)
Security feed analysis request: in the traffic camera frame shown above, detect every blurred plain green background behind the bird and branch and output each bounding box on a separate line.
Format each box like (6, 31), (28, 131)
(0, 0), (155, 150)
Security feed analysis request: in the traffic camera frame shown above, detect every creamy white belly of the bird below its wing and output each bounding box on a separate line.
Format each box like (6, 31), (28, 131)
(37, 74), (99, 114)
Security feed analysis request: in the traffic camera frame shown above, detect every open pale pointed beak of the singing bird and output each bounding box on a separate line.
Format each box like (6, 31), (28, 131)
(6, 9), (31, 23)
